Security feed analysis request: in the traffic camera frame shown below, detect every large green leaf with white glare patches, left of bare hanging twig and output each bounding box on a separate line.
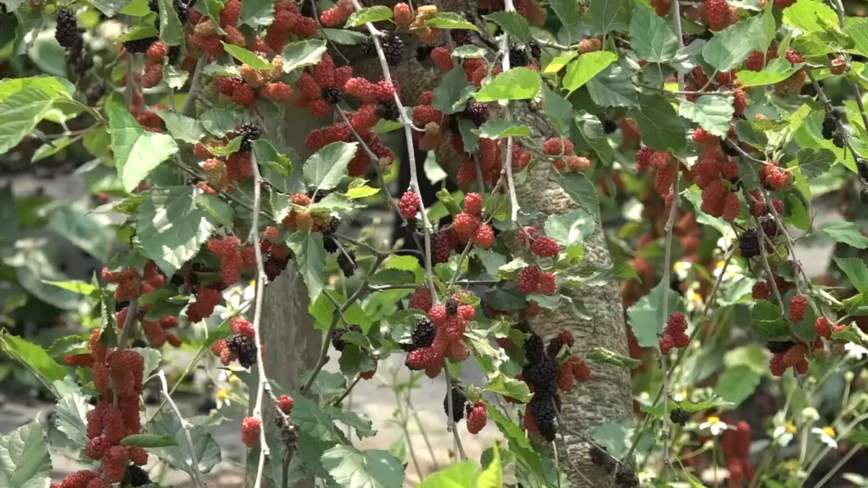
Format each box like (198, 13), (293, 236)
(136, 186), (217, 276)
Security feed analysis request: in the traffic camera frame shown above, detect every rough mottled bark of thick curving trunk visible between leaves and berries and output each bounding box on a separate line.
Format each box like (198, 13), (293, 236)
(351, 5), (632, 488)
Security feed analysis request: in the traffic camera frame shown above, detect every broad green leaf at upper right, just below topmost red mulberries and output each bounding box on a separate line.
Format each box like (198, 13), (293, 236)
(702, 14), (771, 71)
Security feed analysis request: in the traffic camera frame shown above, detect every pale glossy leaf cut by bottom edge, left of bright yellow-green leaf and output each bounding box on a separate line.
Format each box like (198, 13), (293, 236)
(322, 446), (404, 488)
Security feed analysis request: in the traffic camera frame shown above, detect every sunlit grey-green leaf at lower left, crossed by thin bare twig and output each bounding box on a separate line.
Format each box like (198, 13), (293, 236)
(150, 412), (221, 475)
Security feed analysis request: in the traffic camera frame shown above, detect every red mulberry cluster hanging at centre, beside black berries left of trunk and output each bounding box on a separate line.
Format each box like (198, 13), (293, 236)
(404, 297), (476, 378)
